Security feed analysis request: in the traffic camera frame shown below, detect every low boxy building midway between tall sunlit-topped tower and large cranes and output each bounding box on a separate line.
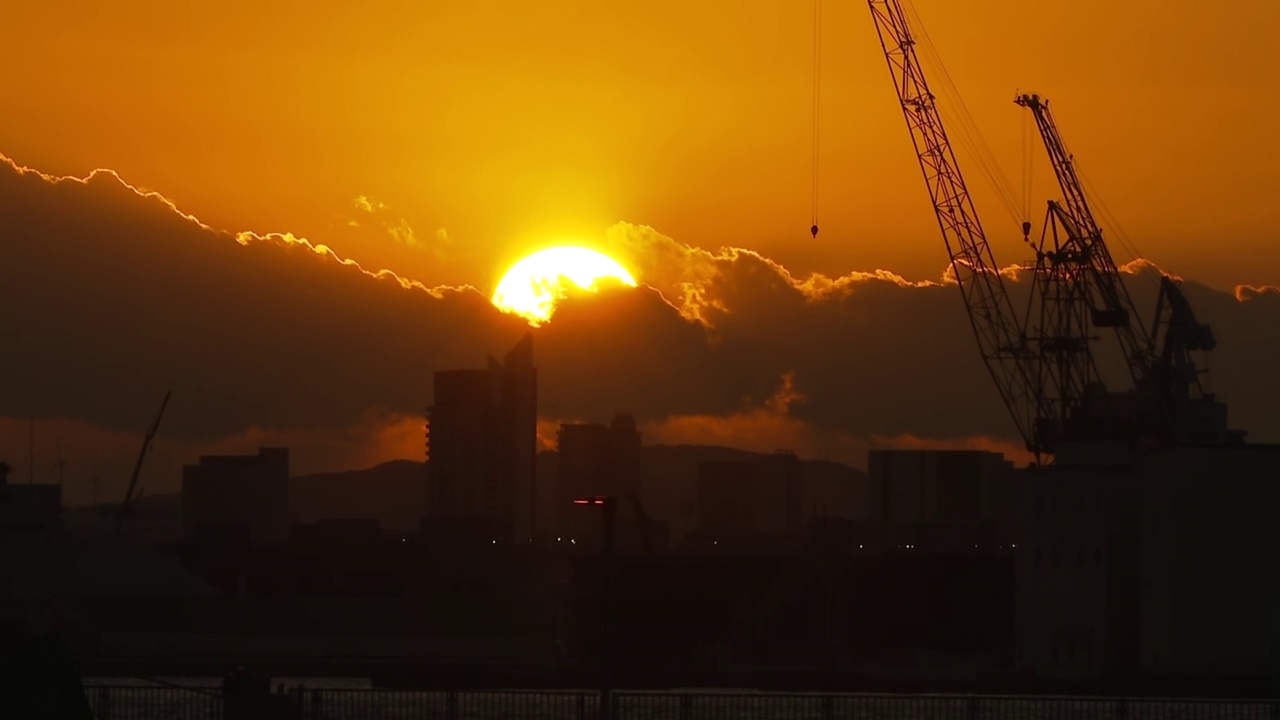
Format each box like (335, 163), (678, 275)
(698, 452), (804, 542)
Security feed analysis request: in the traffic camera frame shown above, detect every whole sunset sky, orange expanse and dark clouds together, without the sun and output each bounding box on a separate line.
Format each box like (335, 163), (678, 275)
(0, 0), (1280, 500)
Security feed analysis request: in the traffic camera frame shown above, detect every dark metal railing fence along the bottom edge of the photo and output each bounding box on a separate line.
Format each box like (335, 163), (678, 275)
(86, 687), (1280, 720)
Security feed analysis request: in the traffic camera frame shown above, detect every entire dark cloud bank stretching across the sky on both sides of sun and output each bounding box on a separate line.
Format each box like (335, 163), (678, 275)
(0, 149), (1280, 497)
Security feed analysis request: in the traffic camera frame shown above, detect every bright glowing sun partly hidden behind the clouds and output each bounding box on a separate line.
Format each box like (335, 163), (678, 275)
(493, 246), (636, 325)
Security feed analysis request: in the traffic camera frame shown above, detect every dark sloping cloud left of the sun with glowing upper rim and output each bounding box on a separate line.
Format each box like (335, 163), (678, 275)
(0, 151), (522, 439)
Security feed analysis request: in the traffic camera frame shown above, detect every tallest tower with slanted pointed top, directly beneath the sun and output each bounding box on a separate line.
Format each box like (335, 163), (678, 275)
(424, 333), (538, 543)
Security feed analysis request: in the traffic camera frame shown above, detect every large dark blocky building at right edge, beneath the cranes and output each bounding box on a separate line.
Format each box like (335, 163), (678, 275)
(1016, 443), (1280, 679)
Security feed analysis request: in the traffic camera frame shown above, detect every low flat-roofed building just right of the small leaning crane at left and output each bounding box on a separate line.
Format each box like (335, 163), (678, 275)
(182, 447), (289, 543)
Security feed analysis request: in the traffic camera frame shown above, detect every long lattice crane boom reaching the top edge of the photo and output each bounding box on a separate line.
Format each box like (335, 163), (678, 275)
(868, 0), (1046, 455)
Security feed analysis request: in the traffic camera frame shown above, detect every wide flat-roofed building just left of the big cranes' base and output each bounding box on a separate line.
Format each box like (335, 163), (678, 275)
(867, 450), (1015, 552)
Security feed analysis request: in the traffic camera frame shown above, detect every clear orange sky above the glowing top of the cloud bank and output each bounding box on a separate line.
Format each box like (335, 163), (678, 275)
(0, 0), (1280, 288)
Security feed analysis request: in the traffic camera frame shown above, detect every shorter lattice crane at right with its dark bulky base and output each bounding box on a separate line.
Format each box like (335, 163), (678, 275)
(1014, 94), (1230, 442)
